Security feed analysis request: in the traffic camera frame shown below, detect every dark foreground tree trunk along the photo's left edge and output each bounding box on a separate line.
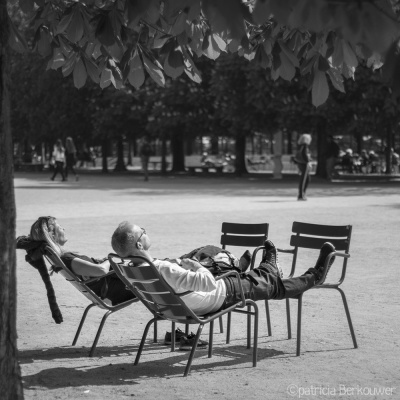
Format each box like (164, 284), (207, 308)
(0, 0), (24, 400)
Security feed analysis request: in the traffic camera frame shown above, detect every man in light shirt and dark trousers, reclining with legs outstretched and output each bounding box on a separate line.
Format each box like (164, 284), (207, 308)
(111, 221), (335, 315)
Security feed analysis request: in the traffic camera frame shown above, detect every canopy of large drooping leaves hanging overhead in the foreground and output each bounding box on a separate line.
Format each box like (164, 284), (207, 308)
(9, 0), (400, 106)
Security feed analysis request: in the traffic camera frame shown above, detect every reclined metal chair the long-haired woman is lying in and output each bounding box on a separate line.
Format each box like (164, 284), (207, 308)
(43, 246), (144, 357)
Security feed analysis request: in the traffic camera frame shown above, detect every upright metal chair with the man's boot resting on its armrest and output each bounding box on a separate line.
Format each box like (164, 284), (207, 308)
(254, 222), (358, 356)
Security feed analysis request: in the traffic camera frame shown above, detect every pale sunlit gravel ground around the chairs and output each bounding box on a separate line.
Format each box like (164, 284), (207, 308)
(15, 174), (400, 399)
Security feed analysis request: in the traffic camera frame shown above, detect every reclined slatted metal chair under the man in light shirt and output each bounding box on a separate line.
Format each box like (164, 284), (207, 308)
(109, 254), (258, 376)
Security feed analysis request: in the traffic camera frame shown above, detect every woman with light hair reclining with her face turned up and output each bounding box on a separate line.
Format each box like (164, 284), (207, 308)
(30, 217), (135, 305)
